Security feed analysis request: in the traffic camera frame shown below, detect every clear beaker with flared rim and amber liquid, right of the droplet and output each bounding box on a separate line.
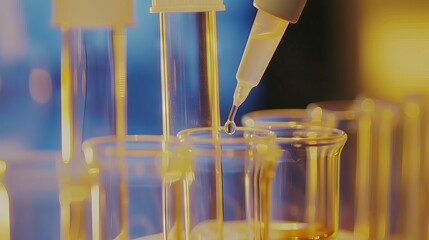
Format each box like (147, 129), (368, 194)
(242, 115), (347, 239)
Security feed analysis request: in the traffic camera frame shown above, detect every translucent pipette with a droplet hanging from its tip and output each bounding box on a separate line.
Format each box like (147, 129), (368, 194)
(225, 0), (307, 134)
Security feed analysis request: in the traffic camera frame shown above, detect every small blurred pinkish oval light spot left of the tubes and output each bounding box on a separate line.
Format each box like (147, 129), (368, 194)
(29, 68), (52, 103)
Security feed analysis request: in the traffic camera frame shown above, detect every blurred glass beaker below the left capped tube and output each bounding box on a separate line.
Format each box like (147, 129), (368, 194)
(83, 135), (188, 239)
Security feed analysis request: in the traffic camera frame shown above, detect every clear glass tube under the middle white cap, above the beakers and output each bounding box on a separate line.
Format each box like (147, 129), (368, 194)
(160, 11), (220, 136)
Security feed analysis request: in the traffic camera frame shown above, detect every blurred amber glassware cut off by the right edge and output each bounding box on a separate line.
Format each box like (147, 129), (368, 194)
(398, 93), (429, 239)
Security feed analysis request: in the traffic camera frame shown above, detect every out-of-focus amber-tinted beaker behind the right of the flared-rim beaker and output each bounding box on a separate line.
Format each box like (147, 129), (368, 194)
(307, 96), (400, 239)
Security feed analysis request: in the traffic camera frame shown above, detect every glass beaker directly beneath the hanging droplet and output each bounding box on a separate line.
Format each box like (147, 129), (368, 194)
(178, 127), (279, 240)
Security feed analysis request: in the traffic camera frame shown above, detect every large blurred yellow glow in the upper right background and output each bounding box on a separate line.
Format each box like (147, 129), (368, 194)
(359, 5), (429, 99)
